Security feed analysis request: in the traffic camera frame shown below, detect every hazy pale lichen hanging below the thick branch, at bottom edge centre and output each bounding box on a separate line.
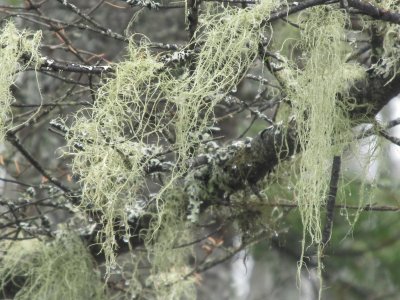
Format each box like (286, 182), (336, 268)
(142, 188), (196, 300)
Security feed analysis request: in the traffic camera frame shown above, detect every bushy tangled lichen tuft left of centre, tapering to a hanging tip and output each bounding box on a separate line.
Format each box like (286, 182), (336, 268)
(68, 43), (168, 268)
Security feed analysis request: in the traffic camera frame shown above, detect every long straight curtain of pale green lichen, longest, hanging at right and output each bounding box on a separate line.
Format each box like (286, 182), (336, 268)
(288, 8), (364, 292)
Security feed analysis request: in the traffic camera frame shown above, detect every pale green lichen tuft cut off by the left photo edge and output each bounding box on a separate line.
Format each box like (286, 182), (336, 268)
(0, 22), (42, 143)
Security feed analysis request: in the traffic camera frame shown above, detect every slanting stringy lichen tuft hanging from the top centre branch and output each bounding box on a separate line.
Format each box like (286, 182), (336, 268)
(171, 0), (278, 162)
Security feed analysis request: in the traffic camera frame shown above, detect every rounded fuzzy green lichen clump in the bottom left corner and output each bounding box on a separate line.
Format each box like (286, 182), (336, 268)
(0, 234), (105, 300)
